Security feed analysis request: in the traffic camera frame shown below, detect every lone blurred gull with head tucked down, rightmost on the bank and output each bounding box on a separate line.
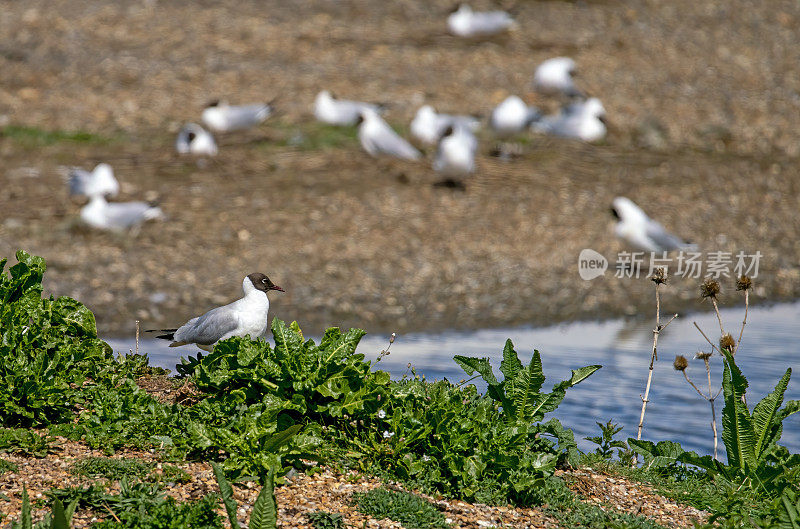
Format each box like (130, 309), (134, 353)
(611, 197), (696, 252)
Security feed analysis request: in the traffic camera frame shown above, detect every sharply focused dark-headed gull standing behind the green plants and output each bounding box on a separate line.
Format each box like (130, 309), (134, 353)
(147, 273), (284, 351)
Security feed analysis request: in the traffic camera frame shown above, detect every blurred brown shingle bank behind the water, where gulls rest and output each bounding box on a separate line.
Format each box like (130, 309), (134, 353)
(0, 1), (800, 335)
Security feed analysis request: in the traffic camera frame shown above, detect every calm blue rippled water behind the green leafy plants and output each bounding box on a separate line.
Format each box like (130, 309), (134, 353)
(108, 302), (800, 454)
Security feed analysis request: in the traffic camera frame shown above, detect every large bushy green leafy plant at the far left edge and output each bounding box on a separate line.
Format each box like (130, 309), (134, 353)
(0, 250), (112, 427)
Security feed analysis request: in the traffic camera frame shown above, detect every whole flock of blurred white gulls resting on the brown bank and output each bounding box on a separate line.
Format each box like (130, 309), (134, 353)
(62, 4), (686, 272)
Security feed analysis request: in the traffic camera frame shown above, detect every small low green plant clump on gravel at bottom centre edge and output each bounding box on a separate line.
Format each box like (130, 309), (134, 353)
(353, 489), (449, 529)
